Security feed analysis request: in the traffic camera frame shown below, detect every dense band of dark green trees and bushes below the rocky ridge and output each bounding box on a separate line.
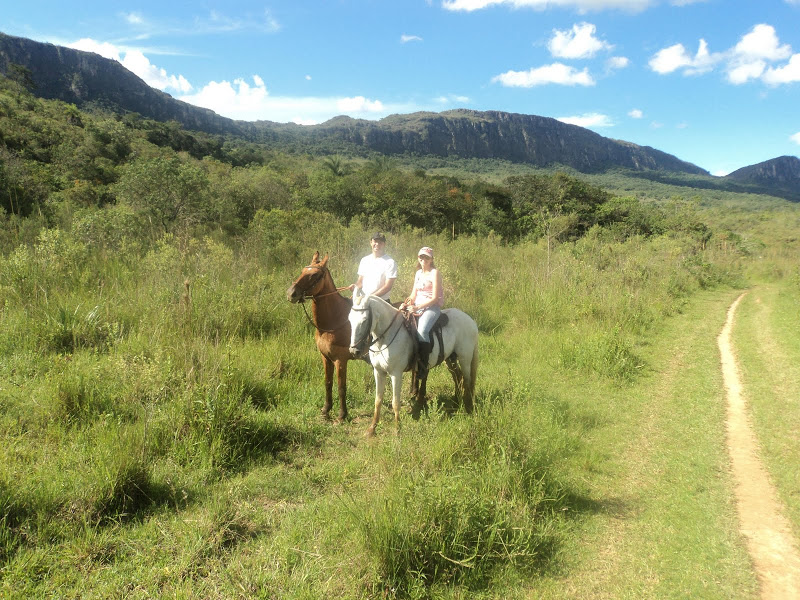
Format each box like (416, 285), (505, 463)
(0, 77), (710, 251)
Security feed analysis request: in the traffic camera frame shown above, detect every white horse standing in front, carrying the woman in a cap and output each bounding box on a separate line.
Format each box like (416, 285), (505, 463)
(348, 288), (478, 436)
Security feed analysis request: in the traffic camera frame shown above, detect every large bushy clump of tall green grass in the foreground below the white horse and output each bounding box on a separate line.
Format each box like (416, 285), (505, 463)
(358, 397), (565, 596)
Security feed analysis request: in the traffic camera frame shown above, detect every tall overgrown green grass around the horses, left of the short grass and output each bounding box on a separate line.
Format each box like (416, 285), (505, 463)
(0, 213), (764, 597)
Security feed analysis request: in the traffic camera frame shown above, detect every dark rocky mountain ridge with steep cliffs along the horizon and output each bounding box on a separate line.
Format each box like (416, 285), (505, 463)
(0, 33), (800, 199)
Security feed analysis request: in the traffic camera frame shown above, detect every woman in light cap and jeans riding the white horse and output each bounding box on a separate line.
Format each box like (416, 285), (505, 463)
(401, 246), (444, 379)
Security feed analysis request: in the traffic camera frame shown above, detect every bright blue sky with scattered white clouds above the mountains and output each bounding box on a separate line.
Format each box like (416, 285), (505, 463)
(0, 0), (800, 174)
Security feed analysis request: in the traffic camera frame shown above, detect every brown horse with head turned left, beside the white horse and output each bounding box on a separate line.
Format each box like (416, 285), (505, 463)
(286, 252), (353, 422)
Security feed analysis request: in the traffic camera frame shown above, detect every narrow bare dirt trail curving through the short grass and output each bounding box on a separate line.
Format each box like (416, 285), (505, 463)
(717, 294), (800, 600)
